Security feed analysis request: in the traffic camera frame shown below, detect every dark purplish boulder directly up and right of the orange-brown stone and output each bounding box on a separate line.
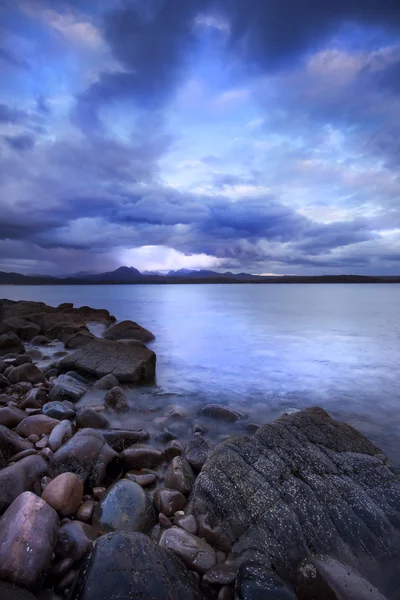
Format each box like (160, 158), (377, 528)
(51, 429), (122, 487)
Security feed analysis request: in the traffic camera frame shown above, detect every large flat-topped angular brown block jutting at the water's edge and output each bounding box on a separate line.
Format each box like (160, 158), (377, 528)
(58, 339), (156, 383)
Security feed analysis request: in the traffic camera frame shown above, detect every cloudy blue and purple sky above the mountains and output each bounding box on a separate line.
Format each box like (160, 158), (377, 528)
(0, 0), (400, 276)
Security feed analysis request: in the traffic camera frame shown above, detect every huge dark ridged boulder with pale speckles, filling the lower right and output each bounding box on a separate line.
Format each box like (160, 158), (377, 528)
(189, 409), (400, 598)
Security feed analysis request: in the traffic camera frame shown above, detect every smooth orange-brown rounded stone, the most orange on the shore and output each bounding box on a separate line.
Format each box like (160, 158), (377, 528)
(42, 473), (83, 517)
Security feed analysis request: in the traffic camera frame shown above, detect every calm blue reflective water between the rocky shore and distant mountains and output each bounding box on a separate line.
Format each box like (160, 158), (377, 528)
(0, 284), (400, 465)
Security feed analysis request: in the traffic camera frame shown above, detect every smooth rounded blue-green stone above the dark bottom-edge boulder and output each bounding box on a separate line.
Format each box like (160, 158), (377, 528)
(93, 479), (157, 533)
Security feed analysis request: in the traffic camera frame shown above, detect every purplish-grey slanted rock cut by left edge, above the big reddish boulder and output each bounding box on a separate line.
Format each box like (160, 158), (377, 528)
(0, 456), (47, 514)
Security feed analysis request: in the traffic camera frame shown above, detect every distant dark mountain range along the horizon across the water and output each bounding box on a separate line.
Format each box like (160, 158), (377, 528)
(0, 267), (400, 285)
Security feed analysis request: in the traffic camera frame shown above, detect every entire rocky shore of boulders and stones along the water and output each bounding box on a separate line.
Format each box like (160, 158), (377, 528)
(0, 300), (400, 600)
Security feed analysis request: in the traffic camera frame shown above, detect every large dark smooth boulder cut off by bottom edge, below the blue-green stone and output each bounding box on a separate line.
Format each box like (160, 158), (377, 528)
(71, 532), (203, 600)
